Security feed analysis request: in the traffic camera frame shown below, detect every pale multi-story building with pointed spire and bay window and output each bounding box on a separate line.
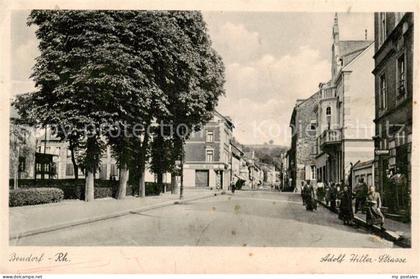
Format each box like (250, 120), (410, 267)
(315, 14), (374, 183)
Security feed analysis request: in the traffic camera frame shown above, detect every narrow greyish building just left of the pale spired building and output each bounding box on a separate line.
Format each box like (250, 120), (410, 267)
(288, 93), (319, 190)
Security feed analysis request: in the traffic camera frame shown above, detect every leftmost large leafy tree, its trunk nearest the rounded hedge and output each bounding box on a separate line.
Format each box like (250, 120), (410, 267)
(15, 11), (156, 200)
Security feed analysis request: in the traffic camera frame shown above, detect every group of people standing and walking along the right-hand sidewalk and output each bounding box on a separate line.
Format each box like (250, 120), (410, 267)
(301, 178), (384, 228)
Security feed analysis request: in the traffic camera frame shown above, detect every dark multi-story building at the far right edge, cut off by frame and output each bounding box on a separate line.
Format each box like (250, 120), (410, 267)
(372, 12), (414, 212)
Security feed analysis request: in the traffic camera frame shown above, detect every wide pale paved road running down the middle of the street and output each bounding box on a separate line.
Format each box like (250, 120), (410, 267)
(10, 191), (393, 248)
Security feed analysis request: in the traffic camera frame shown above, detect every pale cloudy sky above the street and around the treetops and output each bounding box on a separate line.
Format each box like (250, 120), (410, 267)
(11, 11), (373, 145)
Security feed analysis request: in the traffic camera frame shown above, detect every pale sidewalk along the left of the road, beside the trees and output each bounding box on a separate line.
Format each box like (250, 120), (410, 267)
(9, 187), (221, 242)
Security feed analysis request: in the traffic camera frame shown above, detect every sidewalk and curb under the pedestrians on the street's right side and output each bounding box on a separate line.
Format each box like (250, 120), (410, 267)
(318, 200), (411, 248)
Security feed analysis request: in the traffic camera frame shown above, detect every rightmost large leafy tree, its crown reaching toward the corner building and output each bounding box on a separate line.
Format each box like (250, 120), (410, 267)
(152, 11), (225, 195)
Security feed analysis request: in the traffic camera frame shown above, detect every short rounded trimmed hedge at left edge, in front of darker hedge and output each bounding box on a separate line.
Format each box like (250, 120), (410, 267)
(9, 188), (64, 207)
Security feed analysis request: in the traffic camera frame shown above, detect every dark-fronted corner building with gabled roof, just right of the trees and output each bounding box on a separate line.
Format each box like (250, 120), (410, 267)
(183, 111), (234, 189)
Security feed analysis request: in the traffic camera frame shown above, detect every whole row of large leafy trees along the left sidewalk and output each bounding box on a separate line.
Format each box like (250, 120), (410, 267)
(14, 10), (225, 201)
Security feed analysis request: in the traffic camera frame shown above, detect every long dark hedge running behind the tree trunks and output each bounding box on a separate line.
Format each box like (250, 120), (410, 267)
(9, 179), (170, 200)
